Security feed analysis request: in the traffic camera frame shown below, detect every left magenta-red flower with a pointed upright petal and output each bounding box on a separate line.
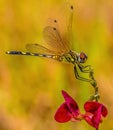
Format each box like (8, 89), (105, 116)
(54, 90), (80, 123)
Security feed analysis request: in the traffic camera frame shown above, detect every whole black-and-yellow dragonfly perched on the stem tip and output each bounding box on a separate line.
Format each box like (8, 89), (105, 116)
(6, 5), (91, 82)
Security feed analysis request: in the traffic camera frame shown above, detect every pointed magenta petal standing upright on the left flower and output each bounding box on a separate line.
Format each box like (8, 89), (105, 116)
(62, 90), (80, 116)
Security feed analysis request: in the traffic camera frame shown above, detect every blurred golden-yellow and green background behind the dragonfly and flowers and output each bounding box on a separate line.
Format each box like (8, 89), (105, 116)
(0, 0), (113, 130)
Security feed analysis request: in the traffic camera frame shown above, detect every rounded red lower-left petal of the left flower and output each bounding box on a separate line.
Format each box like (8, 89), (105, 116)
(54, 103), (71, 123)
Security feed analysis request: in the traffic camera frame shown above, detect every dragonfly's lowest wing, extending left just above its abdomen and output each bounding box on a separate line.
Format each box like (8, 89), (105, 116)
(26, 43), (56, 54)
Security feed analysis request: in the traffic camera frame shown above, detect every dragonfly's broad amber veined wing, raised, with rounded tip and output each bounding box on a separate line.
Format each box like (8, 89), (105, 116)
(43, 26), (69, 54)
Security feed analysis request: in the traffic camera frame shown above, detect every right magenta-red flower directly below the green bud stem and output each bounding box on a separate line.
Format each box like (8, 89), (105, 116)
(84, 101), (108, 130)
